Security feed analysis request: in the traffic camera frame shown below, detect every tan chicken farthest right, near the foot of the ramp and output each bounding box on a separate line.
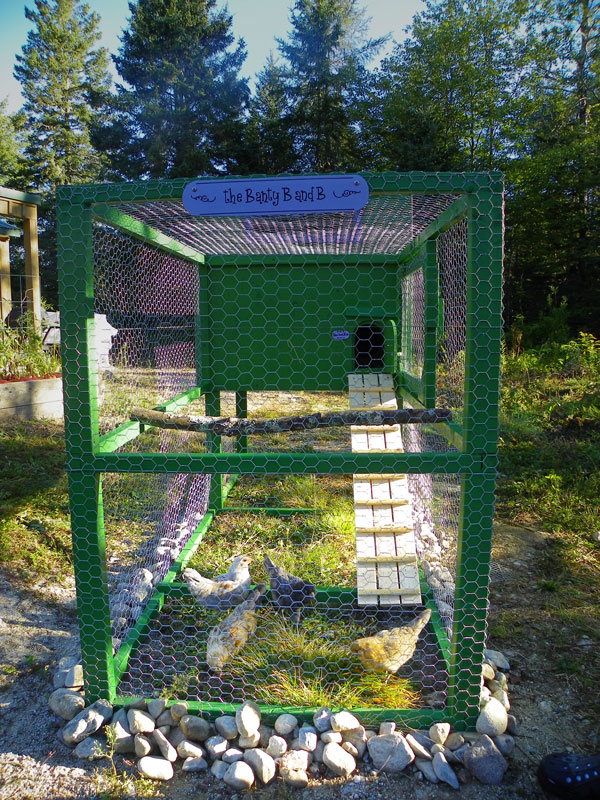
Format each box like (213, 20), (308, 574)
(350, 608), (431, 672)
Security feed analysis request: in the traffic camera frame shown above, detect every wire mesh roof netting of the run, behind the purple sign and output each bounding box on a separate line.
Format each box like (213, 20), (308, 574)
(108, 194), (458, 255)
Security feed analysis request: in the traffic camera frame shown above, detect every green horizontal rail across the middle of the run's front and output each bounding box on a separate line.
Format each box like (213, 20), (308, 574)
(91, 450), (482, 475)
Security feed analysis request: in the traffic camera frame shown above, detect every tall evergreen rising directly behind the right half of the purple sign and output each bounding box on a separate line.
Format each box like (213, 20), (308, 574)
(278, 0), (385, 171)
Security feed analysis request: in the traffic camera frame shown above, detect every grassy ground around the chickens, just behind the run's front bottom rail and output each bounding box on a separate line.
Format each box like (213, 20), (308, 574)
(118, 589), (447, 711)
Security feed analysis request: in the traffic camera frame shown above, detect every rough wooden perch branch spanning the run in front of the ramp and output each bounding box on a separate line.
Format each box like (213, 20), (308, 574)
(130, 408), (452, 436)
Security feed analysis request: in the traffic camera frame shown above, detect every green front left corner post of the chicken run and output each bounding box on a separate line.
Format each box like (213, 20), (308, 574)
(57, 187), (115, 702)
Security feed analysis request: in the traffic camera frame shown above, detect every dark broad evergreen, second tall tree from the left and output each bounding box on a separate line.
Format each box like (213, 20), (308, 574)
(112, 0), (248, 177)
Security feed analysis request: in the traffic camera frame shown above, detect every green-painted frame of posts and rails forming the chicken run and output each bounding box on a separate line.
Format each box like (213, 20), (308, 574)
(58, 173), (503, 728)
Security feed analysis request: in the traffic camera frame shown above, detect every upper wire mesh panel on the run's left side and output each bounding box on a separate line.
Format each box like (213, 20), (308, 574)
(94, 226), (199, 433)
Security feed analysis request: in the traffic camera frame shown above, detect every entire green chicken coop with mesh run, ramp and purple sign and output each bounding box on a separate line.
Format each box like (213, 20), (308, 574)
(58, 172), (503, 728)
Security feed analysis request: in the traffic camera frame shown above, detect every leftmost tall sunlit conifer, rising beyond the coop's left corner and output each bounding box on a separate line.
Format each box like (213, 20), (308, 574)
(14, 0), (110, 192)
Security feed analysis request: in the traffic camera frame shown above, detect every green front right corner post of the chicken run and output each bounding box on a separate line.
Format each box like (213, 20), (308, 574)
(448, 174), (503, 727)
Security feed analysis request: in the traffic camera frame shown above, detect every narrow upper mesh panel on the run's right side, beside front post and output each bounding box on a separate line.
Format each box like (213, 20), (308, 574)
(437, 220), (467, 420)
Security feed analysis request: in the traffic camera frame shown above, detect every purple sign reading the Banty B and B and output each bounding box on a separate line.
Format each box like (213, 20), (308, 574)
(183, 175), (369, 217)
